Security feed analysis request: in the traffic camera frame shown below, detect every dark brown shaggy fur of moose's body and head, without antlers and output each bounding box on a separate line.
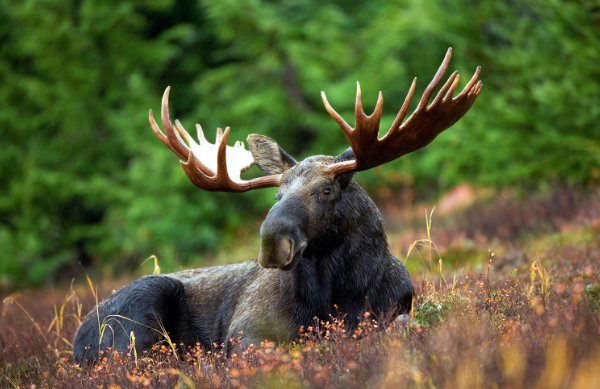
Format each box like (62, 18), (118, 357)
(73, 141), (413, 362)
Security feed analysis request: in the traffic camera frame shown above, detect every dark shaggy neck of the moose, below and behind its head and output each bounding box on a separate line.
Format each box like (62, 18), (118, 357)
(280, 182), (391, 321)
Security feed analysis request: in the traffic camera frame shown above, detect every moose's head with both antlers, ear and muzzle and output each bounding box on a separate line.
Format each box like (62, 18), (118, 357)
(149, 48), (482, 270)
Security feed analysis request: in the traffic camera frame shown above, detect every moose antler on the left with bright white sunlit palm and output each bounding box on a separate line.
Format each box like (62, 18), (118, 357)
(148, 87), (281, 192)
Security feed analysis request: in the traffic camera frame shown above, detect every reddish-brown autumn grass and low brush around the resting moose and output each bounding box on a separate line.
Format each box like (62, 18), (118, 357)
(0, 185), (600, 389)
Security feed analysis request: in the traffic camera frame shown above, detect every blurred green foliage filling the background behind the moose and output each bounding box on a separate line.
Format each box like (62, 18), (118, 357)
(0, 0), (600, 289)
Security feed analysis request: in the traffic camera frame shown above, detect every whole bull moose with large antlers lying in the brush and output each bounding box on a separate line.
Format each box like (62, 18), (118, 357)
(73, 48), (482, 362)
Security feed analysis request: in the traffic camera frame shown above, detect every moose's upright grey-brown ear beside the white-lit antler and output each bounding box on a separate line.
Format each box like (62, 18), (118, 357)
(246, 134), (296, 174)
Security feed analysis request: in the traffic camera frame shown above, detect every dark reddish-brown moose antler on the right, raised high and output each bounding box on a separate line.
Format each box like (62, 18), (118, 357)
(321, 48), (482, 175)
